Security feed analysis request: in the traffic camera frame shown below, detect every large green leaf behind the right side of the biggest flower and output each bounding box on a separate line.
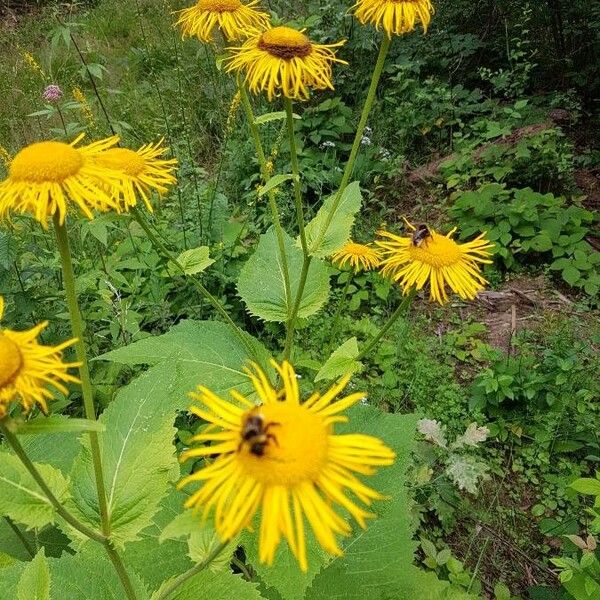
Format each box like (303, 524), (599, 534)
(307, 406), (424, 600)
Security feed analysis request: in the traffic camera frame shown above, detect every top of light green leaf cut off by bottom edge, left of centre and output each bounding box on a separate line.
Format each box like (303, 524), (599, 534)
(152, 569), (262, 600)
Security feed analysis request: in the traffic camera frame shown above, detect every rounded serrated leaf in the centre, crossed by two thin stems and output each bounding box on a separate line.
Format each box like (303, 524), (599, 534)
(238, 229), (329, 323)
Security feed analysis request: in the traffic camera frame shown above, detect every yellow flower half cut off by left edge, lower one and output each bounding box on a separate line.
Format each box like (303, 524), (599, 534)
(0, 296), (79, 418)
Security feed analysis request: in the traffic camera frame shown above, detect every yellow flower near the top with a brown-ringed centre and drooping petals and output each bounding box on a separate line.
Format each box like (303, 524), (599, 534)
(227, 27), (347, 101)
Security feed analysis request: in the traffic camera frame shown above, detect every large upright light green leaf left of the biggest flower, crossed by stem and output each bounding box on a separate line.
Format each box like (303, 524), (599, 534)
(72, 366), (182, 546)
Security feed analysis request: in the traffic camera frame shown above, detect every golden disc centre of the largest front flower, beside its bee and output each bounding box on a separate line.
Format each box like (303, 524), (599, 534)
(239, 402), (329, 485)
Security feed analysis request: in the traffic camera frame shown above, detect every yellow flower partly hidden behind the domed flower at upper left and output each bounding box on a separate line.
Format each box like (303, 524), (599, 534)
(95, 140), (177, 212)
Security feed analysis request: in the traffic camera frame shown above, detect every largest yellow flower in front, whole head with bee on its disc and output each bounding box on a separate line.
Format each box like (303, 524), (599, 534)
(180, 361), (395, 571)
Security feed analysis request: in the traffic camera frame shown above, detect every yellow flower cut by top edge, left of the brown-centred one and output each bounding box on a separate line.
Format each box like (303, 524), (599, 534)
(177, 0), (269, 42)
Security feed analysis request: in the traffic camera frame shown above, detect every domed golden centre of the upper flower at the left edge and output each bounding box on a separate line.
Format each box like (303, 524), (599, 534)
(10, 142), (84, 183)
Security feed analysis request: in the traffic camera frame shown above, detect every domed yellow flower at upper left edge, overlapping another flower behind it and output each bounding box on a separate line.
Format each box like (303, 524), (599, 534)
(0, 135), (121, 228)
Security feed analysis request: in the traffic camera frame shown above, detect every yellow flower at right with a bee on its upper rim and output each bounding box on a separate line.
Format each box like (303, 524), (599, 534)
(376, 223), (494, 304)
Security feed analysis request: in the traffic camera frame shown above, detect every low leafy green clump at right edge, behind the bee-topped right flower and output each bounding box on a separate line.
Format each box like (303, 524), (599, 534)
(450, 184), (600, 296)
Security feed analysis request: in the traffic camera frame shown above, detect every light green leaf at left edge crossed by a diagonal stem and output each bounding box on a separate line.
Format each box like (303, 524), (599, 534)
(0, 451), (69, 529)
